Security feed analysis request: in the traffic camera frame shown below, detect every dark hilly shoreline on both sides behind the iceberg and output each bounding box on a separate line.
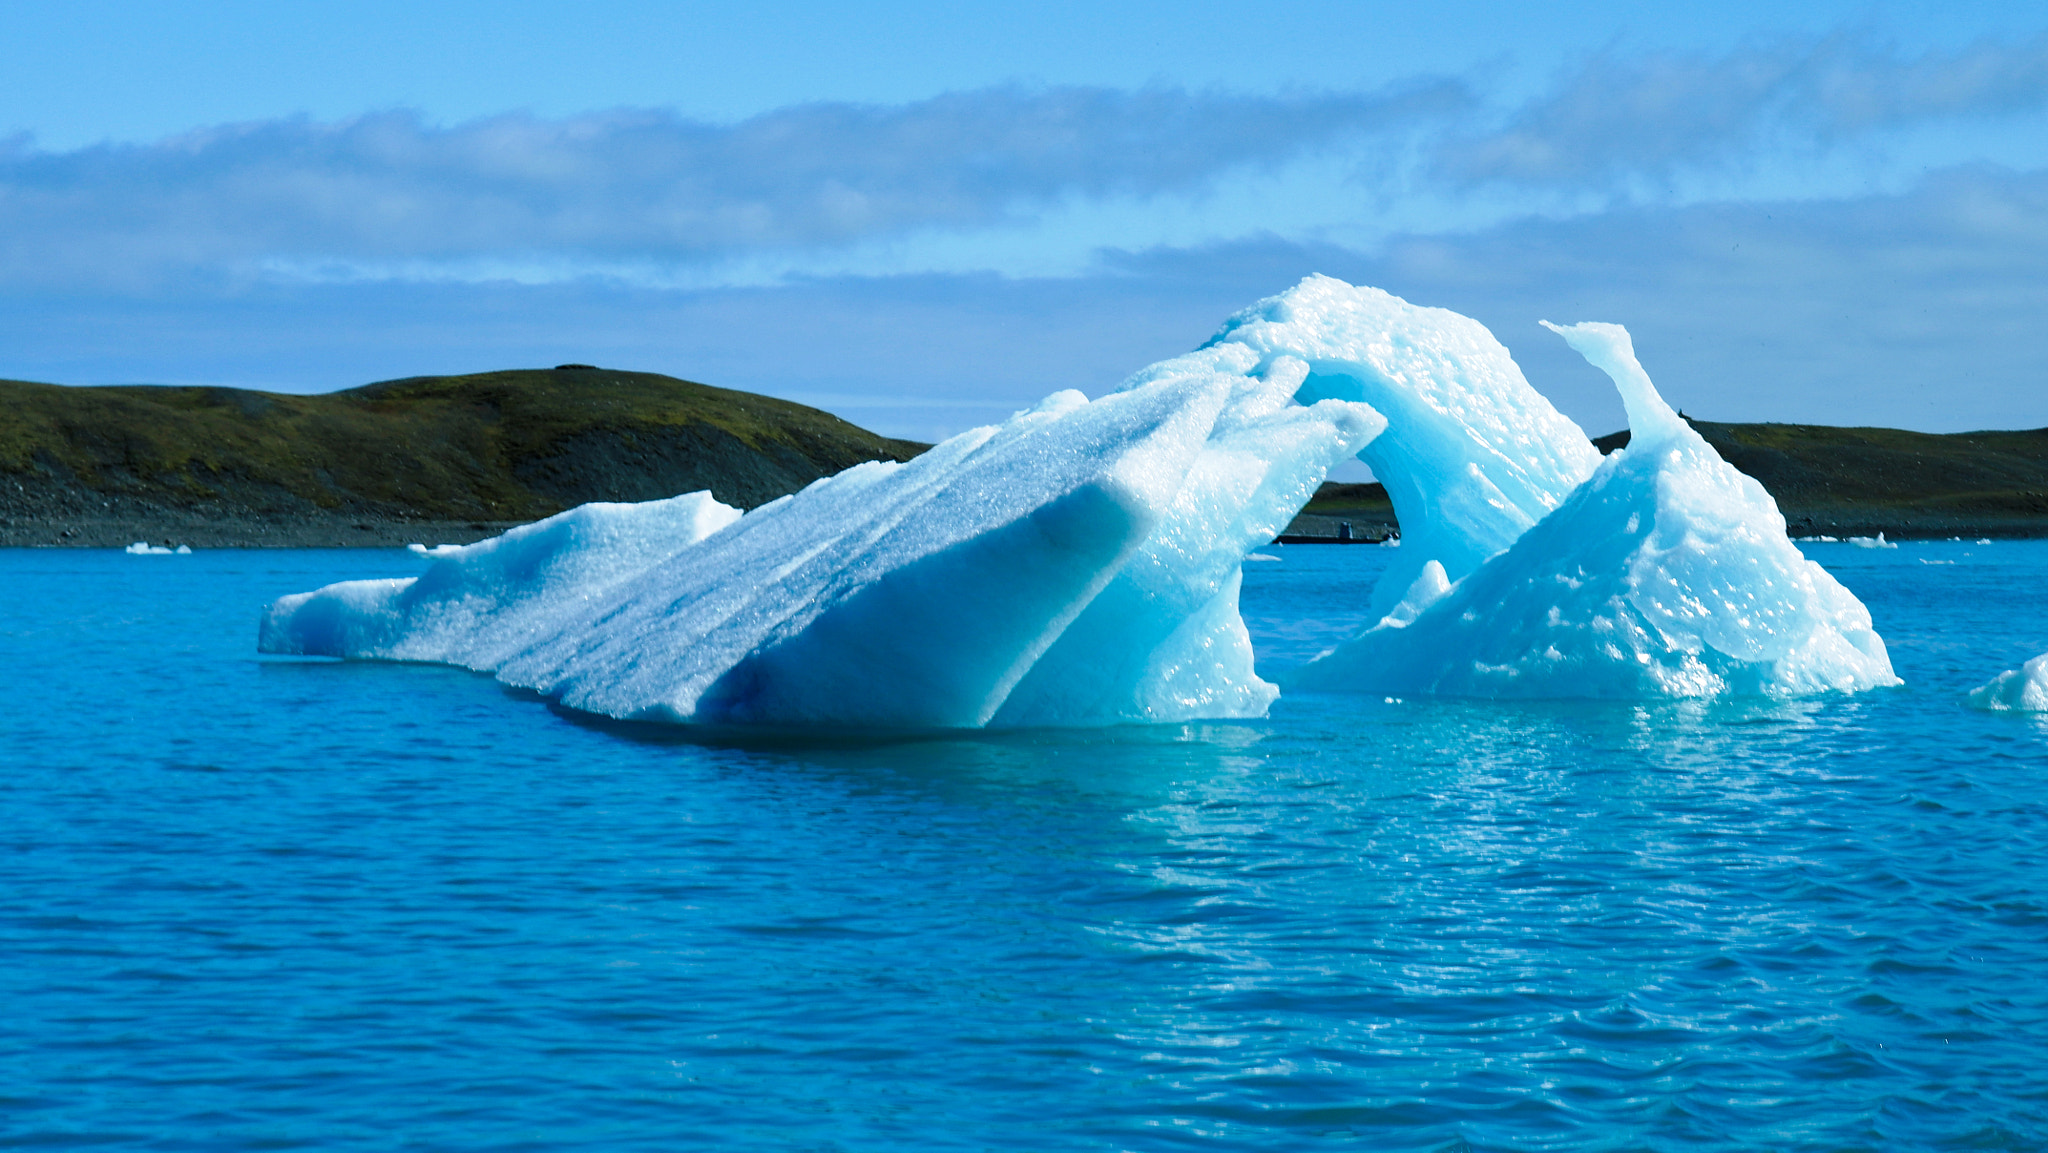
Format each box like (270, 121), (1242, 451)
(0, 365), (2048, 549)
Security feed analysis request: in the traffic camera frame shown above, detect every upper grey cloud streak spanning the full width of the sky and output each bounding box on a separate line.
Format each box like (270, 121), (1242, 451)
(0, 35), (2048, 297)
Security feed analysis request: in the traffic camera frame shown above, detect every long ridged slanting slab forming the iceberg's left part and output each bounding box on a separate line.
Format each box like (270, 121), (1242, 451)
(260, 352), (1382, 729)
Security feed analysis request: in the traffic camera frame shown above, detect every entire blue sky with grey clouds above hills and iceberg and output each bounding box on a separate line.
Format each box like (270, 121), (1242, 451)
(0, 0), (2048, 440)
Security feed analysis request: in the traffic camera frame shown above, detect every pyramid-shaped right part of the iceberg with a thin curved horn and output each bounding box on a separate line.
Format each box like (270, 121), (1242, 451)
(1298, 315), (1898, 698)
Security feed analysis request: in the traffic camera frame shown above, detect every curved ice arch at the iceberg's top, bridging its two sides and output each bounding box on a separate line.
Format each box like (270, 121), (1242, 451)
(1210, 276), (1599, 612)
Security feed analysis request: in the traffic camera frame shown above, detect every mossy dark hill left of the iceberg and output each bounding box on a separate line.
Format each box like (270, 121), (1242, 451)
(0, 365), (926, 547)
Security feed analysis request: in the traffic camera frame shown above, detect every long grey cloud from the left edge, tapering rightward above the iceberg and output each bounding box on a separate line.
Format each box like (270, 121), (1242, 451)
(0, 80), (1470, 285)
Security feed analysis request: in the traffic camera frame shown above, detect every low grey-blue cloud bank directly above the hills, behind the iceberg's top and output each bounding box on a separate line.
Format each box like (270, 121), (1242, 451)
(16, 159), (2048, 438)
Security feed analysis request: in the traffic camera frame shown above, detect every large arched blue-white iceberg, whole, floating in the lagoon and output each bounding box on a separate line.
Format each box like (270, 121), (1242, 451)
(260, 276), (1896, 729)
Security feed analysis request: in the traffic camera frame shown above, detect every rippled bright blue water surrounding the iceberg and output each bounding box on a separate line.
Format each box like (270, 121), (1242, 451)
(0, 543), (2048, 1151)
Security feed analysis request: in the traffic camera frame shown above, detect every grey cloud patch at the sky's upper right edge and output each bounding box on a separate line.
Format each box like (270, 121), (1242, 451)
(1432, 35), (2048, 188)
